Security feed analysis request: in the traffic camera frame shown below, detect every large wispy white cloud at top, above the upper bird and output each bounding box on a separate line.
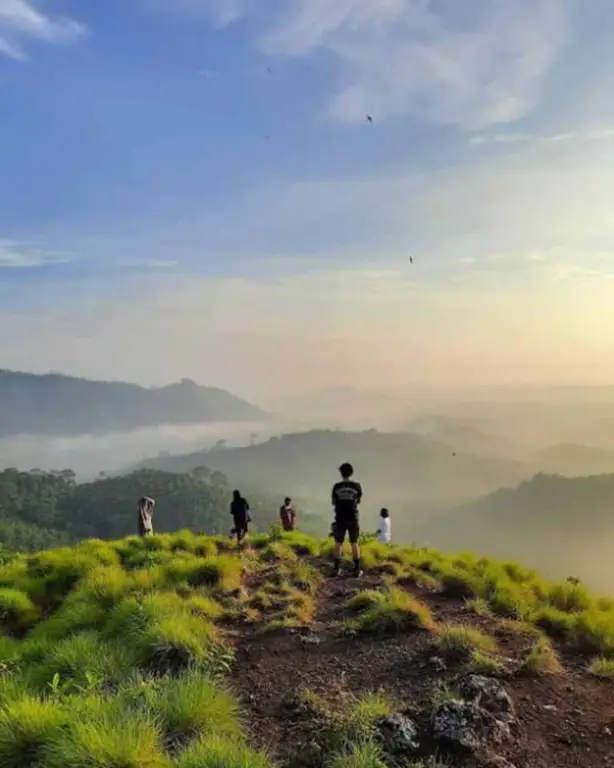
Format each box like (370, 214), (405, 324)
(192, 0), (569, 129)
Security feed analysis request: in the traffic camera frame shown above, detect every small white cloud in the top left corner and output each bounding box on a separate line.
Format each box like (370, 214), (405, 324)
(0, 0), (86, 59)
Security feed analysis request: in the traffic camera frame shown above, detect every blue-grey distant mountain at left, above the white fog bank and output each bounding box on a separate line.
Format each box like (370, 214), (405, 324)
(0, 371), (266, 437)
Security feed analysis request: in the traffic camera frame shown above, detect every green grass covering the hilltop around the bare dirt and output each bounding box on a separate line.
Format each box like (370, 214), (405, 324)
(0, 531), (614, 768)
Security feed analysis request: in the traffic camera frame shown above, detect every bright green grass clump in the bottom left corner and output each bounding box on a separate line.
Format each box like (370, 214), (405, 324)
(0, 696), (67, 768)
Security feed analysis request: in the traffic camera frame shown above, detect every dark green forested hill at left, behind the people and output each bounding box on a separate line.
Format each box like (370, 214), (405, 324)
(0, 468), (323, 551)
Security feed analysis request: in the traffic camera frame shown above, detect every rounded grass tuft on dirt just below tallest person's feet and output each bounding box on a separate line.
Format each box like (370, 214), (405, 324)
(347, 587), (435, 634)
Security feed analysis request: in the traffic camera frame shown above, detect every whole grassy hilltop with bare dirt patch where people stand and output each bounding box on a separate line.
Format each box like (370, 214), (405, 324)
(0, 531), (614, 768)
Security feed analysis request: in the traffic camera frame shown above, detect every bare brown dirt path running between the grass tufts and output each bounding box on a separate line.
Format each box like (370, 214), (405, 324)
(232, 576), (614, 768)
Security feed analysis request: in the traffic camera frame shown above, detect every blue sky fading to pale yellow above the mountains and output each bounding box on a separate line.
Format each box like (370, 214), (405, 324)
(0, 0), (614, 401)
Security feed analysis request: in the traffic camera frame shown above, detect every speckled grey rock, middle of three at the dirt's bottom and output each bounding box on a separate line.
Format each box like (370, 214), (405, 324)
(431, 699), (511, 752)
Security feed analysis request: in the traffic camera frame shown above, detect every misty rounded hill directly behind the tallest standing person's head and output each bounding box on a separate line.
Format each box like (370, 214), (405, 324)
(135, 430), (529, 516)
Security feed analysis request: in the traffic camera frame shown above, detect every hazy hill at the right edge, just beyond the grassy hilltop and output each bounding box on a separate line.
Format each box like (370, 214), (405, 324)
(415, 474), (614, 590)
